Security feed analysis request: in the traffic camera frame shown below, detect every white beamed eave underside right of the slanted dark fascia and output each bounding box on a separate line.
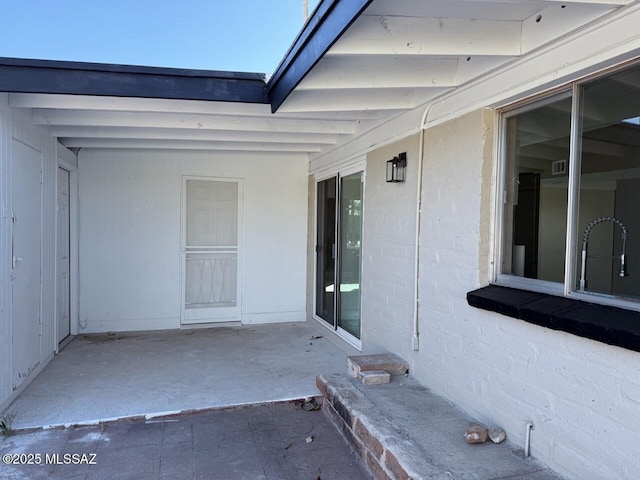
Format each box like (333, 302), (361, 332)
(278, 0), (629, 118)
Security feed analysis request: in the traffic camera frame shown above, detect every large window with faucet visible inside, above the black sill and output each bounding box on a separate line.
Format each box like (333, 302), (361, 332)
(498, 65), (640, 302)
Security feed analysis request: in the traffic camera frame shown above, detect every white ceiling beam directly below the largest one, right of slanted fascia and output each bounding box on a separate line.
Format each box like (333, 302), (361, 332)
(296, 55), (458, 91)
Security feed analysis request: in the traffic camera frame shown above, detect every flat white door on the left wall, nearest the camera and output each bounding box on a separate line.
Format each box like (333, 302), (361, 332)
(11, 140), (42, 388)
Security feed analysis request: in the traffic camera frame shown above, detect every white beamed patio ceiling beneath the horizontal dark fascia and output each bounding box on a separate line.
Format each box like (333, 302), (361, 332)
(9, 93), (390, 154)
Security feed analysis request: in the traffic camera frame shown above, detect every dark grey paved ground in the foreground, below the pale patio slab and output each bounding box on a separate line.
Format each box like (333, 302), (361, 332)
(0, 403), (370, 480)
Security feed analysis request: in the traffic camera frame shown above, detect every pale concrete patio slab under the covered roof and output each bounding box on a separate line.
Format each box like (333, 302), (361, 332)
(6, 323), (347, 429)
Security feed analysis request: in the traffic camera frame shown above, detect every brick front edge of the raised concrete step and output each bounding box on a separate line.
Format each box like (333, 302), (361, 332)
(316, 374), (444, 480)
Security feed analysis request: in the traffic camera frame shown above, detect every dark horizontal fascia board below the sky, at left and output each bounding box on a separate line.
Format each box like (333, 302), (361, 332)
(0, 58), (269, 104)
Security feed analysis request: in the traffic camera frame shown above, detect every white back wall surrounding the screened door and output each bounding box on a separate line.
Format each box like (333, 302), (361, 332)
(79, 150), (308, 333)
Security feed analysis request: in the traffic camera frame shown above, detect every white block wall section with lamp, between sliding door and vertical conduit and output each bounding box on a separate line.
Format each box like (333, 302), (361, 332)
(362, 135), (420, 358)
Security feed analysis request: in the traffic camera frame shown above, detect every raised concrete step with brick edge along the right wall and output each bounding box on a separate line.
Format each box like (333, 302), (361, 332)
(316, 374), (560, 480)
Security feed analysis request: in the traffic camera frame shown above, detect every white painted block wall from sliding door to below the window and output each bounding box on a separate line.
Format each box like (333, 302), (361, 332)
(363, 110), (640, 480)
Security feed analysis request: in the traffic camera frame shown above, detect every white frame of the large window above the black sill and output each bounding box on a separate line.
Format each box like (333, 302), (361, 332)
(498, 59), (640, 311)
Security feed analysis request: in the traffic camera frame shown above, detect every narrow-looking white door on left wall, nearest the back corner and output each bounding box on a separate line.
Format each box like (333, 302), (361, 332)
(56, 168), (71, 343)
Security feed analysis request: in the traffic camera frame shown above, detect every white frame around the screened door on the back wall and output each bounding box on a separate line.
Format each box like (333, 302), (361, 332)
(180, 175), (244, 327)
